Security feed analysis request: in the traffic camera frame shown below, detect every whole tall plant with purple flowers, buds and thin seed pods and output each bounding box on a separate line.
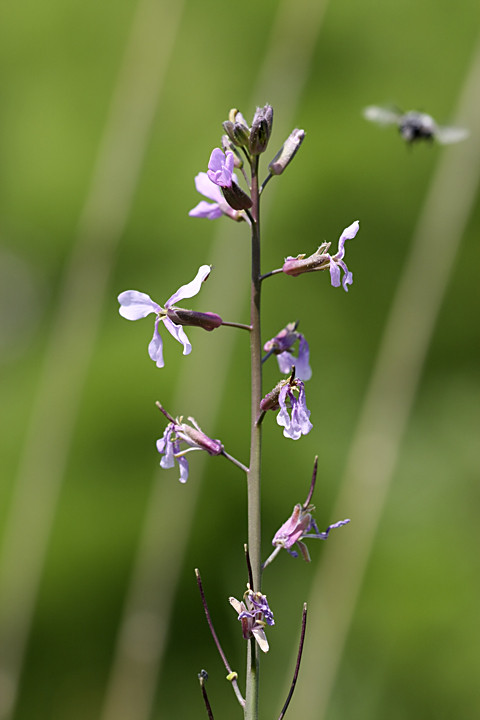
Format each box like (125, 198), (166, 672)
(118, 105), (359, 720)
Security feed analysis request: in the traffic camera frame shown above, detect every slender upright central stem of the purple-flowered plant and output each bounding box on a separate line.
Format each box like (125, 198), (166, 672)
(245, 156), (262, 720)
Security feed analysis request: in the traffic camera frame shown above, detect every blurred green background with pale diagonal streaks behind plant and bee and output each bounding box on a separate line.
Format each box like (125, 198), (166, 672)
(0, 0), (480, 720)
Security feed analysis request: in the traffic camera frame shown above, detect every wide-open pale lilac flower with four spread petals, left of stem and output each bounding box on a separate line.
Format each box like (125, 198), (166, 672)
(118, 265), (222, 367)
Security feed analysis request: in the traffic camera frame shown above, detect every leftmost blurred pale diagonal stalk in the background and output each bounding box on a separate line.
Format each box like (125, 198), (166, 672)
(0, 0), (183, 720)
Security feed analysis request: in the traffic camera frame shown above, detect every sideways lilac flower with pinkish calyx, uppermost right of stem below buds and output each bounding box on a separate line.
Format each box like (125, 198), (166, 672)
(282, 220), (360, 292)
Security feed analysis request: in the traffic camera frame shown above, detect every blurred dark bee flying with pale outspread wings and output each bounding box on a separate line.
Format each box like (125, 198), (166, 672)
(363, 105), (469, 145)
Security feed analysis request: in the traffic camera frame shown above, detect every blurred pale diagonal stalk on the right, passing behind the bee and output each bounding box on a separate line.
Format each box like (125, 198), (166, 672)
(287, 31), (480, 720)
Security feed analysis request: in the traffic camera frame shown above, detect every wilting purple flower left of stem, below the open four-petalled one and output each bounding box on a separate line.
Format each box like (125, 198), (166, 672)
(157, 417), (223, 482)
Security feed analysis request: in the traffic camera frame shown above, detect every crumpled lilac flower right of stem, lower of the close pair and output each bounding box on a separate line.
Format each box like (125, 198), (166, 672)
(260, 372), (313, 440)
